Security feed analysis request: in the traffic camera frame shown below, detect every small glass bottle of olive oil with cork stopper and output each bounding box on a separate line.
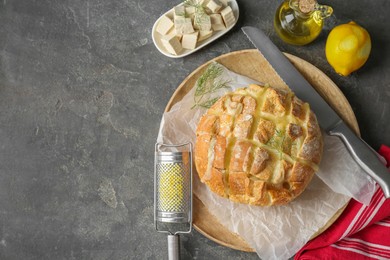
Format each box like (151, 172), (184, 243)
(274, 0), (333, 45)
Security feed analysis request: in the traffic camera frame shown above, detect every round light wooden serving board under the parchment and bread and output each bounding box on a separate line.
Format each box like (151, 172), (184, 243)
(165, 49), (359, 252)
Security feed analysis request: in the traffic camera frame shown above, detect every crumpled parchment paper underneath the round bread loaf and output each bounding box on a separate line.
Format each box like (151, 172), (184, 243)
(157, 63), (375, 259)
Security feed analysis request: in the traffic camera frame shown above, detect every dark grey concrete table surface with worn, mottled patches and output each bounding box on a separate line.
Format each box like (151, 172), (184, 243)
(0, 0), (390, 259)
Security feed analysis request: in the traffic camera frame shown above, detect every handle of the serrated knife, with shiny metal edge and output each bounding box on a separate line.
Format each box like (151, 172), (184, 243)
(329, 122), (390, 198)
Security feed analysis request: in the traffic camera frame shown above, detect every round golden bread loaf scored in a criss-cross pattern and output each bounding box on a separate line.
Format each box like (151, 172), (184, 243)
(195, 85), (323, 206)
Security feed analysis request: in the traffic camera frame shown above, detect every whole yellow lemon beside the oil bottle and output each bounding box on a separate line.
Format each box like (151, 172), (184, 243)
(325, 22), (371, 76)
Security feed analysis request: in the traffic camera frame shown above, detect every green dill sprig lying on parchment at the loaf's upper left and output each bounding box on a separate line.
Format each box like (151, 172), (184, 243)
(192, 63), (229, 108)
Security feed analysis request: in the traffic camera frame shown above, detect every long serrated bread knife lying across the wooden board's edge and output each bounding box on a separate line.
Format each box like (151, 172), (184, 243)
(242, 26), (390, 198)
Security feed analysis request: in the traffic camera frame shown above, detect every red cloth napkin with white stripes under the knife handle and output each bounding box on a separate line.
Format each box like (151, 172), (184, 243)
(294, 145), (390, 260)
